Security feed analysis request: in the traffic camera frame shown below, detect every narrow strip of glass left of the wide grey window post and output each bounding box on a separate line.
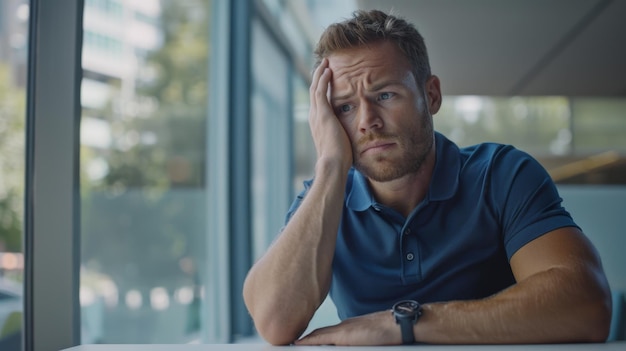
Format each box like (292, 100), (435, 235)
(0, 0), (29, 351)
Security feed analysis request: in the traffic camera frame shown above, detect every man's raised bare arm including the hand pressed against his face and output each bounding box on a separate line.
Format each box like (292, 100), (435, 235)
(243, 60), (352, 345)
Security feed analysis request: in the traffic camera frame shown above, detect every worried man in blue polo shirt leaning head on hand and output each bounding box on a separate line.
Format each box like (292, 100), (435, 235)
(243, 11), (611, 345)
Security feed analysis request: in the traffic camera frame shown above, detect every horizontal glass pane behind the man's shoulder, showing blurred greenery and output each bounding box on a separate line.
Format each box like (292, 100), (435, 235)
(435, 96), (626, 184)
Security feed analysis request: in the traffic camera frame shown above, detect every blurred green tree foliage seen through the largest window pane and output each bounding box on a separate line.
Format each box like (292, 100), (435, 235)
(93, 1), (209, 189)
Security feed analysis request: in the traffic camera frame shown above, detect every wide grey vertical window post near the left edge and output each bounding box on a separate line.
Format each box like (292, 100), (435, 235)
(23, 0), (83, 351)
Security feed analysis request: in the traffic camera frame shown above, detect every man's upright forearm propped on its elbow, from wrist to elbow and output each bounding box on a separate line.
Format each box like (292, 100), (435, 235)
(244, 160), (346, 344)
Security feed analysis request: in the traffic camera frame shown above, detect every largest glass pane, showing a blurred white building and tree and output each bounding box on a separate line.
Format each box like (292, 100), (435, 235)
(80, 0), (211, 344)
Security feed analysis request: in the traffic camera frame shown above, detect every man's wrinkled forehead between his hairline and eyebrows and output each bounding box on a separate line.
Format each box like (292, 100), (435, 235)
(328, 41), (412, 88)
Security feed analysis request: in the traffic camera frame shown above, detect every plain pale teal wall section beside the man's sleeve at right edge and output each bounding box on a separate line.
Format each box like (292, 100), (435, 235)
(559, 185), (626, 292)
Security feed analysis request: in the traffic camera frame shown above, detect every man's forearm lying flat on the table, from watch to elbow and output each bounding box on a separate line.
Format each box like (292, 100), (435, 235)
(415, 268), (610, 344)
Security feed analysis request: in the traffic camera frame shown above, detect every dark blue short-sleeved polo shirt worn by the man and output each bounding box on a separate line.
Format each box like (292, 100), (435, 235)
(287, 133), (576, 319)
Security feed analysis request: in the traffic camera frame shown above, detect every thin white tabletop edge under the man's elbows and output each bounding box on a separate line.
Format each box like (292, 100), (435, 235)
(64, 341), (626, 351)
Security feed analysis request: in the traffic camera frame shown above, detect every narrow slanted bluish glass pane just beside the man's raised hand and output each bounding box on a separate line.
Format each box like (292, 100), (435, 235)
(251, 20), (291, 260)
